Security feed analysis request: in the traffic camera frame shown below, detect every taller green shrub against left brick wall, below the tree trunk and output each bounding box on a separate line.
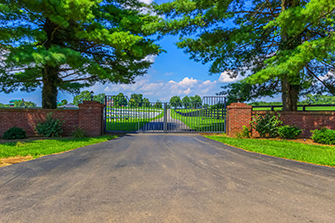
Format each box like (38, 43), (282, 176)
(35, 113), (63, 137)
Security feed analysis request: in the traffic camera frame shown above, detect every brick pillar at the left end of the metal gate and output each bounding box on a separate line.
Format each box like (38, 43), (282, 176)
(78, 101), (105, 137)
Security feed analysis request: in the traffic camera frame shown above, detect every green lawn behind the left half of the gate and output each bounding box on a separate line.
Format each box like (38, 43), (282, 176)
(106, 110), (164, 132)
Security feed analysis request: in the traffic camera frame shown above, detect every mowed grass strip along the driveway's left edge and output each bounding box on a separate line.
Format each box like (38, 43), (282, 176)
(0, 136), (117, 158)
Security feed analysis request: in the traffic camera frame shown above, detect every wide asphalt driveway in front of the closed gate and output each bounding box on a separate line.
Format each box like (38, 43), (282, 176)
(0, 134), (335, 223)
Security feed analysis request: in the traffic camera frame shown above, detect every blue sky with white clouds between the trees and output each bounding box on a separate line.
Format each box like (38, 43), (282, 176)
(0, 0), (244, 105)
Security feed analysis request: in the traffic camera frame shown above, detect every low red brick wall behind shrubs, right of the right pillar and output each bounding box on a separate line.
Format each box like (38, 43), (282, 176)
(252, 111), (335, 138)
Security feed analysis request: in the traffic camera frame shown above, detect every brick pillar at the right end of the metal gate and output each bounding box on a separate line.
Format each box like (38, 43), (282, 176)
(227, 103), (252, 137)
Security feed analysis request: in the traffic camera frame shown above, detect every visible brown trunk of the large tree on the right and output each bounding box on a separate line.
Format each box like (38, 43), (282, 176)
(280, 0), (301, 111)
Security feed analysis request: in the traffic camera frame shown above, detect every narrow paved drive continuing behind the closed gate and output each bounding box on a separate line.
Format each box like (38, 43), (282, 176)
(140, 109), (195, 132)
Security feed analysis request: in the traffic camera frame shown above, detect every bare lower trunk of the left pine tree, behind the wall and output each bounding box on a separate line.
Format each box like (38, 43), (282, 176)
(42, 66), (59, 109)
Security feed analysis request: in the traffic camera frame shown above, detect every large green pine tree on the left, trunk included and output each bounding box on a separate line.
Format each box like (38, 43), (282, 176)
(0, 0), (161, 109)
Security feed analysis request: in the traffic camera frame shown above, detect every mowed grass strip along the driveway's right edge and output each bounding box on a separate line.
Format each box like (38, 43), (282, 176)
(205, 136), (335, 166)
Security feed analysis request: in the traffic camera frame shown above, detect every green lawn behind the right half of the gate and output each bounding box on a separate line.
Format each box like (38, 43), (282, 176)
(170, 109), (224, 132)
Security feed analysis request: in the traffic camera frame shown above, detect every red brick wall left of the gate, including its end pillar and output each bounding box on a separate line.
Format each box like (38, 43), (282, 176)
(0, 101), (104, 137)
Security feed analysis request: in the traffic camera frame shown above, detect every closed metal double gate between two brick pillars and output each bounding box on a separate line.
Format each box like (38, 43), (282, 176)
(104, 96), (227, 133)
